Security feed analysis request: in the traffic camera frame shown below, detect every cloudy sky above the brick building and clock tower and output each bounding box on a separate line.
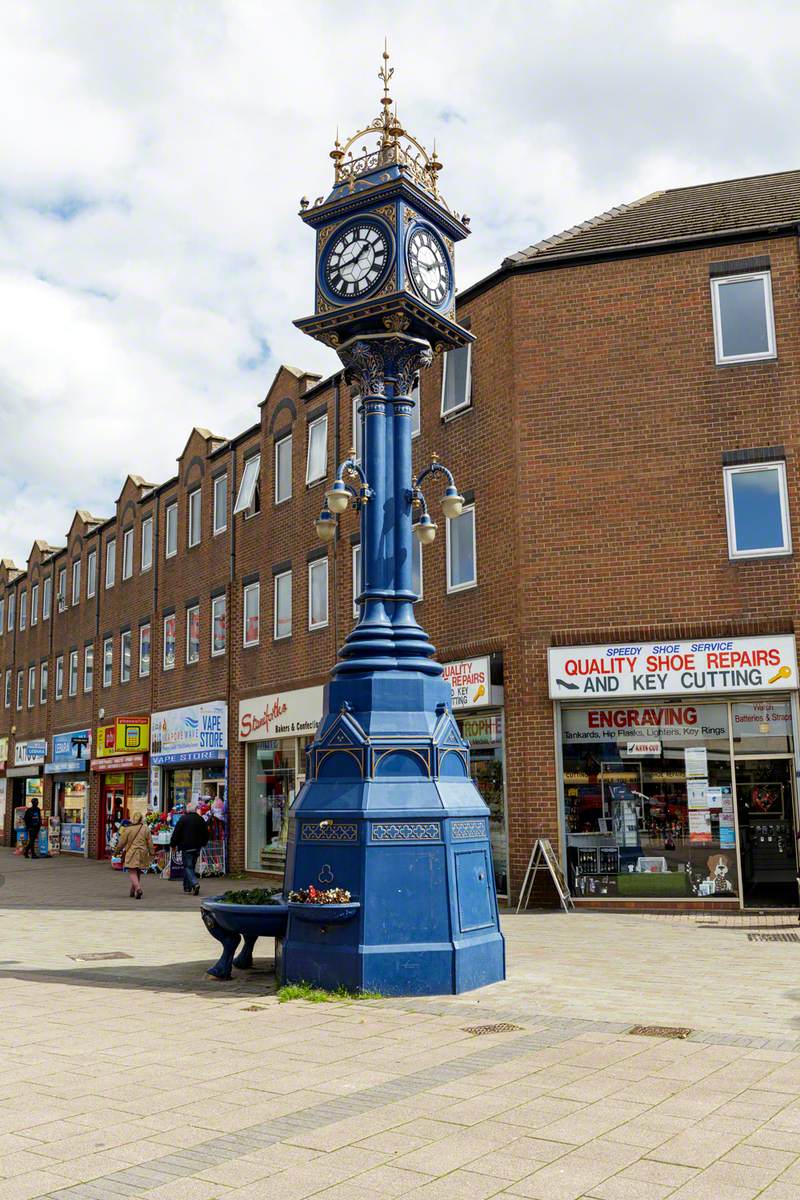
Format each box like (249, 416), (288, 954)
(0, 0), (800, 565)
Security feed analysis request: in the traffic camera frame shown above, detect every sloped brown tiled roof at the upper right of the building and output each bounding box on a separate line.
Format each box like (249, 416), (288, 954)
(503, 170), (800, 268)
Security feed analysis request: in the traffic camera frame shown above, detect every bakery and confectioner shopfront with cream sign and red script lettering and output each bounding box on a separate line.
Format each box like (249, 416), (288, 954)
(239, 688), (323, 872)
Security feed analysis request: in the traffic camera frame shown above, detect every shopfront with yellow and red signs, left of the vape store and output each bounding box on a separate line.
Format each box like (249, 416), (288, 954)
(91, 716), (150, 858)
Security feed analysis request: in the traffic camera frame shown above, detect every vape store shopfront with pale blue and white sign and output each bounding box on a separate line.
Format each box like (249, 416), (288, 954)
(150, 700), (228, 875)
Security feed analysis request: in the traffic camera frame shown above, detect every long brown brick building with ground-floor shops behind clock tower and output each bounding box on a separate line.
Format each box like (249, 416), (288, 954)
(0, 172), (800, 906)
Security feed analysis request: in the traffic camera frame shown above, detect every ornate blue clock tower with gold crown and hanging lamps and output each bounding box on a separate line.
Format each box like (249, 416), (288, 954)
(282, 50), (505, 995)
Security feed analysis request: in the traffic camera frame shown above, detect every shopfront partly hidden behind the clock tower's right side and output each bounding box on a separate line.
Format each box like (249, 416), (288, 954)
(444, 655), (509, 896)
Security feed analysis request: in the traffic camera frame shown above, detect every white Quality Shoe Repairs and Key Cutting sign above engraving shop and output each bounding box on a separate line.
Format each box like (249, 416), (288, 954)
(548, 635), (798, 700)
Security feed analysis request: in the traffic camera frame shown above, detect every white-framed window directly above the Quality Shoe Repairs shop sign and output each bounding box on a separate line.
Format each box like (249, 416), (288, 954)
(724, 462), (792, 558)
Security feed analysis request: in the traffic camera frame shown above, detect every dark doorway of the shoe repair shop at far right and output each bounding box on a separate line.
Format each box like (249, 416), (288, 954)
(735, 757), (798, 908)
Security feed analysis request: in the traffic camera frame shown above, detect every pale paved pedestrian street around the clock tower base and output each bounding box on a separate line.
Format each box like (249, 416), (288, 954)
(0, 850), (800, 1200)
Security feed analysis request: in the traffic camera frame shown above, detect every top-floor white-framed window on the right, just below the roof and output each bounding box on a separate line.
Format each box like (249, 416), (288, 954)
(711, 271), (776, 364)
